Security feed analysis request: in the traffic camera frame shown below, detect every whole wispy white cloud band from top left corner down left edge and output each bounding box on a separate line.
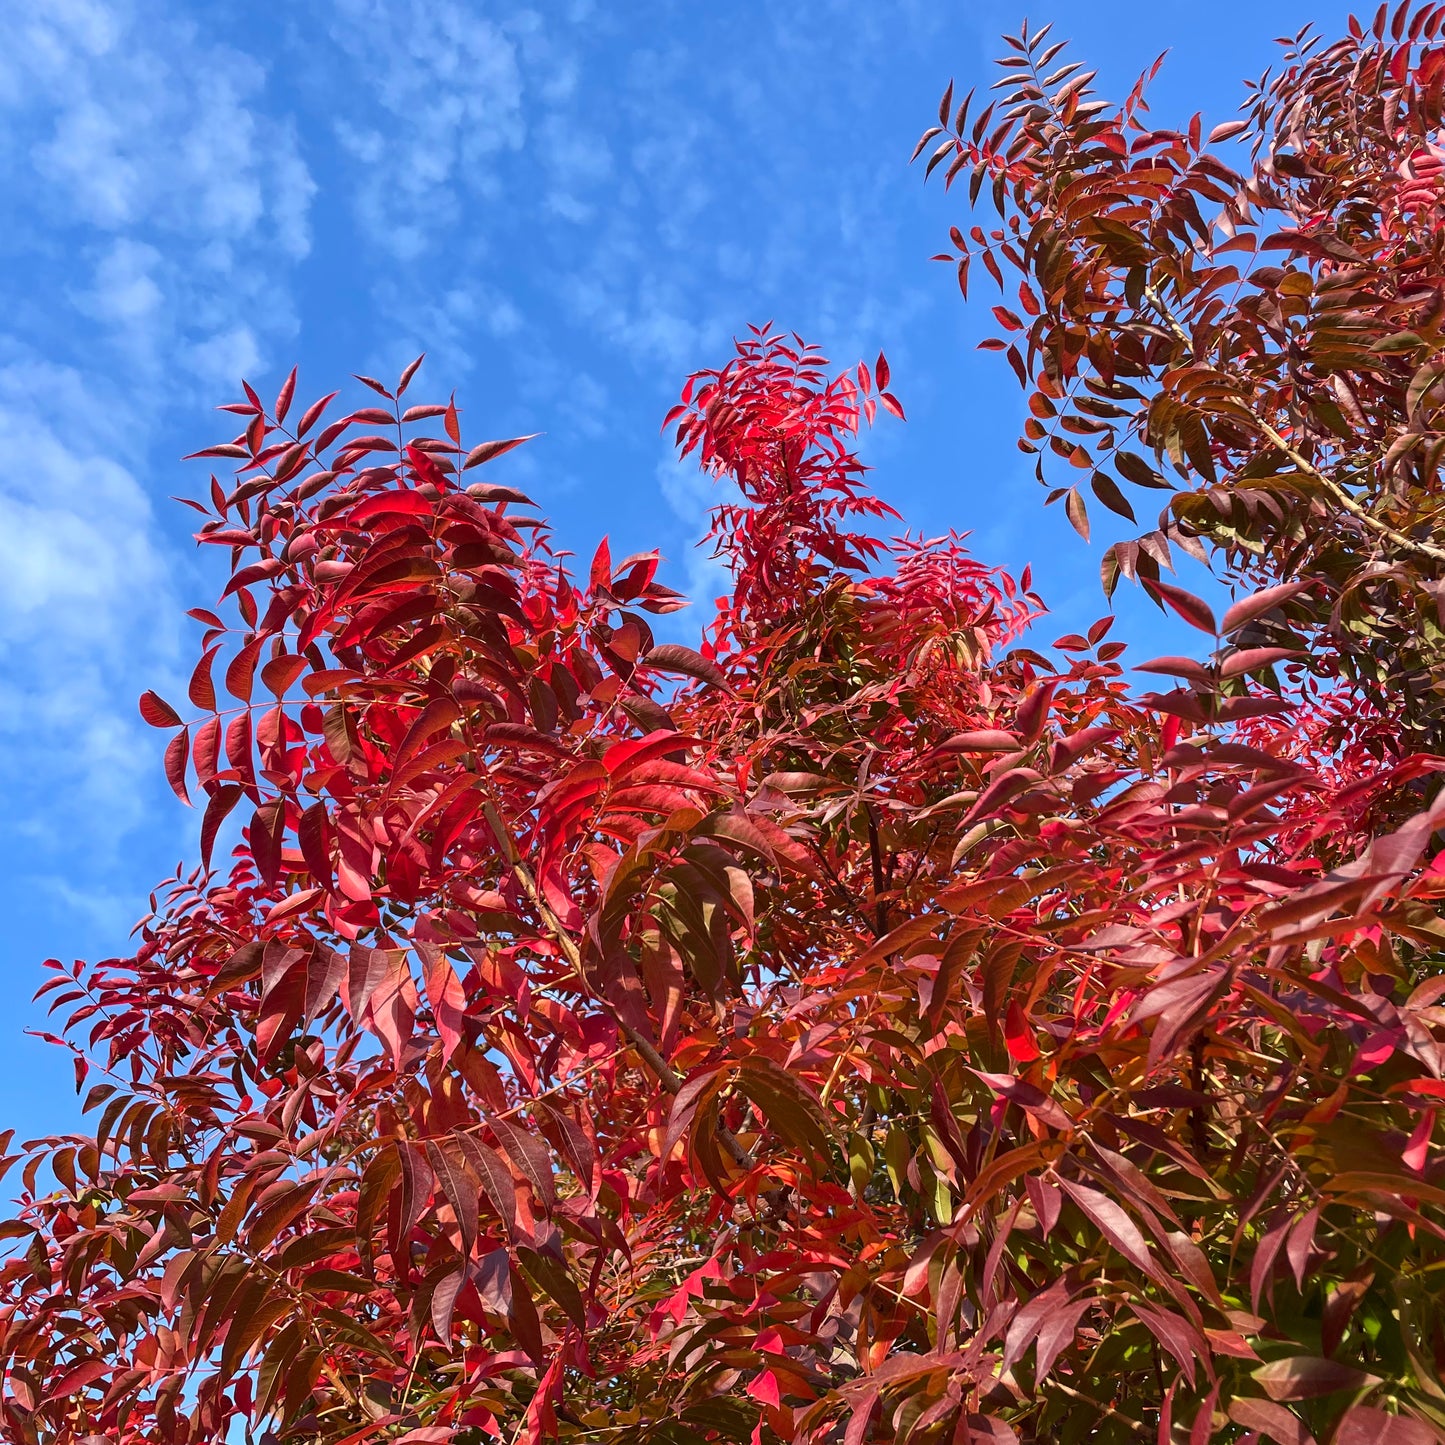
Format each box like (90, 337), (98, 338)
(0, 0), (315, 896)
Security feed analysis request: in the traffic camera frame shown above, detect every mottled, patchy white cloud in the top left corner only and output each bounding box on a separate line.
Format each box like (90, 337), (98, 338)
(0, 0), (315, 386)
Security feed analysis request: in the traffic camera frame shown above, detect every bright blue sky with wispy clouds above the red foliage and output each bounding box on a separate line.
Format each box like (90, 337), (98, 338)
(0, 0), (1347, 1133)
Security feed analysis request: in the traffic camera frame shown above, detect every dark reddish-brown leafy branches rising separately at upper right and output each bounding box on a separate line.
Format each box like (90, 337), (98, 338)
(915, 0), (1445, 751)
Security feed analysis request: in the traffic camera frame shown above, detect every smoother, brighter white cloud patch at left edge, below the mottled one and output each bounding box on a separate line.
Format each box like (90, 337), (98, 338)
(0, 355), (175, 854)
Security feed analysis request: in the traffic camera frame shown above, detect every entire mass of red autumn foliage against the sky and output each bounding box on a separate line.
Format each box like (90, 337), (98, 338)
(0, 6), (1445, 1445)
